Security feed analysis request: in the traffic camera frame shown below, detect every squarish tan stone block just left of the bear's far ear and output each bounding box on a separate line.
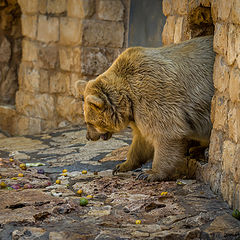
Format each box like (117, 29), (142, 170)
(50, 72), (70, 93)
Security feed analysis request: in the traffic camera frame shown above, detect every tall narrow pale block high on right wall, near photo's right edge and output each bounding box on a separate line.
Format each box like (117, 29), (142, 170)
(226, 24), (237, 65)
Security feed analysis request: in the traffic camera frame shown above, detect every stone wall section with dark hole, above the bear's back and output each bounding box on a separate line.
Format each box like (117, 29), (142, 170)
(162, 0), (214, 45)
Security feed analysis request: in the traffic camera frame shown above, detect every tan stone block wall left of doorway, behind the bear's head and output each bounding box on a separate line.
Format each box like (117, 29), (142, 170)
(7, 0), (128, 134)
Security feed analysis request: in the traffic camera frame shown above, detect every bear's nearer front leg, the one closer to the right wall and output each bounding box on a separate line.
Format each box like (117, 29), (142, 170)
(138, 139), (186, 182)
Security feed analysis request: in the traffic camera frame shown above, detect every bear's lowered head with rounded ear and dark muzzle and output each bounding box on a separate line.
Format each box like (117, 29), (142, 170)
(80, 75), (133, 141)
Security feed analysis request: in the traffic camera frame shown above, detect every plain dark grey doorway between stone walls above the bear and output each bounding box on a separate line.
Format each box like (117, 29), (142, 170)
(128, 0), (166, 47)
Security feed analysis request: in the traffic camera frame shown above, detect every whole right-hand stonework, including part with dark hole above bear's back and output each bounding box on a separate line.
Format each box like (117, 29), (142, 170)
(162, 0), (240, 209)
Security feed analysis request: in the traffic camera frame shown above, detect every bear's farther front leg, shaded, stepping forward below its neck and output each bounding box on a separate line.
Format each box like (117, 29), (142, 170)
(113, 129), (154, 174)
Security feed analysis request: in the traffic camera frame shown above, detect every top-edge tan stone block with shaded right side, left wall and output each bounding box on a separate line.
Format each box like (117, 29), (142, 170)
(67, 0), (95, 18)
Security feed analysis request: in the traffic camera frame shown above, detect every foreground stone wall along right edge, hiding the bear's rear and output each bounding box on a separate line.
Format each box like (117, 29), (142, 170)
(205, 0), (240, 209)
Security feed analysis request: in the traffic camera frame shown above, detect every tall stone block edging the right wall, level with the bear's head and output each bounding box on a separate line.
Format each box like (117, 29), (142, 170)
(212, 94), (228, 131)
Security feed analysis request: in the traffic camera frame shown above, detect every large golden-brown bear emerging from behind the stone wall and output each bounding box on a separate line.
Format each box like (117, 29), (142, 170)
(81, 36), (215, 181)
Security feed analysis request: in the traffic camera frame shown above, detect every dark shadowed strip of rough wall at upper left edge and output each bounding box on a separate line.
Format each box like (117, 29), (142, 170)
(0, 0), (22, 105)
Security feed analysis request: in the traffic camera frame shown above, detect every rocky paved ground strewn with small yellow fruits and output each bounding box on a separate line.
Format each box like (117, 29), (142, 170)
(0, 128), (240, 240)
